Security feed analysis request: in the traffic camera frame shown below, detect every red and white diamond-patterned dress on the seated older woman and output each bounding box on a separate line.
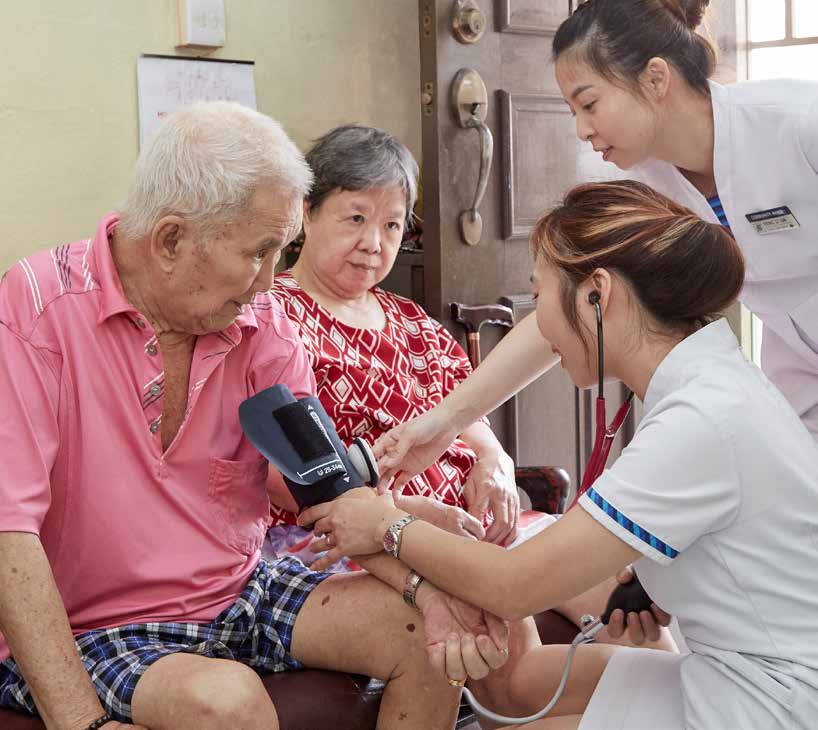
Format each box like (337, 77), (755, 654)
(273, 272), (476, 524)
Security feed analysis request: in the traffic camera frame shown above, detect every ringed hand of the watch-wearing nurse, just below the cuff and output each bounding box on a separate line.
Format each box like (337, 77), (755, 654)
(298, 487), (406, 570)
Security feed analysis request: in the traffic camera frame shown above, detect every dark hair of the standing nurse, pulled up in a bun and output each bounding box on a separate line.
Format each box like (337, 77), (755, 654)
(552, 0), (716, 96)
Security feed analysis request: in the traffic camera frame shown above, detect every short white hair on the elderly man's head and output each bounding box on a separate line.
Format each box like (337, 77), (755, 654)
(119, 101), (312, 239)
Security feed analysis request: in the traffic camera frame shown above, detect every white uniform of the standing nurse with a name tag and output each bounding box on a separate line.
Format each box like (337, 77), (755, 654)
(632, 80), (818, 438)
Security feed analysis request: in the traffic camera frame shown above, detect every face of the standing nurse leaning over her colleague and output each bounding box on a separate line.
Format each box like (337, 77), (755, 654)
(556, 53), (658, 170)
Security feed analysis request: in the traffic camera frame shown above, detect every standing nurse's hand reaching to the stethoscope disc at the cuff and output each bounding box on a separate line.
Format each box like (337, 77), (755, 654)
(372, 406), (457, 492)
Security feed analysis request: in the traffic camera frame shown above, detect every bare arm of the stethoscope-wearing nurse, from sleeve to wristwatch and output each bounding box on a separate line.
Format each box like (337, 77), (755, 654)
(396, 506), (642, 620)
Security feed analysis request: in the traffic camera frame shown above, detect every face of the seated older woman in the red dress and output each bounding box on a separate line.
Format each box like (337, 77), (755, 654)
(301, 185), (406, 299)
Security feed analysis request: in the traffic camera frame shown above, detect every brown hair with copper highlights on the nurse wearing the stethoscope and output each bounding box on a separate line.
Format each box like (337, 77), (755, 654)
(531, 180), (744, 347)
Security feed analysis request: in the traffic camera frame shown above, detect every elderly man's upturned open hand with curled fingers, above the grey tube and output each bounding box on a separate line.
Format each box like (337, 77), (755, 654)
(415, 581), (509, 681)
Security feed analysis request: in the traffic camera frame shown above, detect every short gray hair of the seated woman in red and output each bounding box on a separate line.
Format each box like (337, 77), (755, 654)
(307, 124), (418, 223)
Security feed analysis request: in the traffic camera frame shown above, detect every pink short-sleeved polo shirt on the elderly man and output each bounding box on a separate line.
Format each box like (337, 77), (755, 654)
(0, 216), (315, 660)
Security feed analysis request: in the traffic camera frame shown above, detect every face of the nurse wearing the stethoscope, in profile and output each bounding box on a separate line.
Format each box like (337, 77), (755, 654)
(531, 256), (596, 388)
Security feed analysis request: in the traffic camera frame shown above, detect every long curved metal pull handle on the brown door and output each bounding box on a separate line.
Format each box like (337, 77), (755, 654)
(452, 68), (494, 246)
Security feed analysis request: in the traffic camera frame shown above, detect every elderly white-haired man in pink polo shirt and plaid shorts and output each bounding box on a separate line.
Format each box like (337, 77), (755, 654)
(0, 102), (507, 730)
